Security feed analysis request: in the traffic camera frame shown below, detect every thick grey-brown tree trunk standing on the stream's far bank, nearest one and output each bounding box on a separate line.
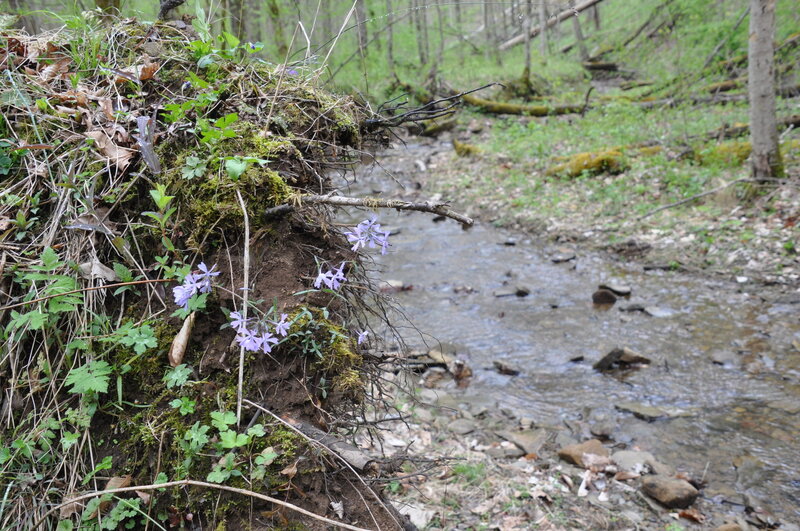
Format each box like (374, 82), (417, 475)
(747, 0), (783, 180)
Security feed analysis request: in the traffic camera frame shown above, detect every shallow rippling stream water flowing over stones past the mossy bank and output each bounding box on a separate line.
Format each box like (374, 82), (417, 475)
(345, 140), (800, 521)
